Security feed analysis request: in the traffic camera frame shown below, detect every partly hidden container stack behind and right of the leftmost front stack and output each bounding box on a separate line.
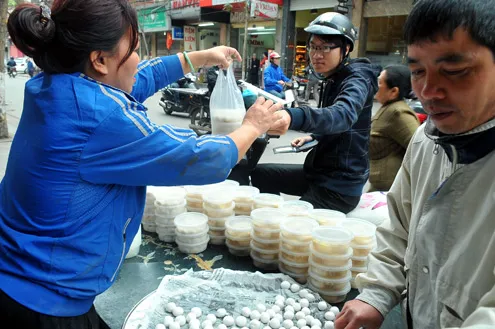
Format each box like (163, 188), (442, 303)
(203, 187), (235, 245)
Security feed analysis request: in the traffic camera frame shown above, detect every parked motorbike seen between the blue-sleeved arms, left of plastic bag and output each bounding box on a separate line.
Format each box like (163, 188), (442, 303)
(158, 73), (200, 115)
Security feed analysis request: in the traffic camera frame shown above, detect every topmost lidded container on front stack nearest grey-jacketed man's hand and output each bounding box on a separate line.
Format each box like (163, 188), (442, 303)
(313, 226), (354, 255)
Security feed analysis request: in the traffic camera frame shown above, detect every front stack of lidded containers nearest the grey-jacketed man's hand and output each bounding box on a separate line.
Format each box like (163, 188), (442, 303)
(308, 226), (354, 303)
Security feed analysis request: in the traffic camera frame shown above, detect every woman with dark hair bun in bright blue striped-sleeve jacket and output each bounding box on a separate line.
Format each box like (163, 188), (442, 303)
(0, 0), (280, 328)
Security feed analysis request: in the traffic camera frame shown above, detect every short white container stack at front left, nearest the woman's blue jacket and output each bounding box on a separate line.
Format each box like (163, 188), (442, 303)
(174, 212), (210, 254)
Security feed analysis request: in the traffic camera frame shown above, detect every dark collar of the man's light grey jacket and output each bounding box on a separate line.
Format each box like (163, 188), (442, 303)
(425, 118), (495, 164)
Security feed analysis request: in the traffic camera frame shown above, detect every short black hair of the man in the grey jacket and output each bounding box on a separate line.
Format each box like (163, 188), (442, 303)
(404, 0), (495, 56)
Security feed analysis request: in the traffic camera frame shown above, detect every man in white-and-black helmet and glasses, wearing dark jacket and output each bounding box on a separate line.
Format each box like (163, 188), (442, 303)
(251, 12), (380, 213)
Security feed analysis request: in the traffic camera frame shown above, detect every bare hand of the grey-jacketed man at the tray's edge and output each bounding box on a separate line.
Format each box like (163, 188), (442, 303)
(335, 299), (383, 329)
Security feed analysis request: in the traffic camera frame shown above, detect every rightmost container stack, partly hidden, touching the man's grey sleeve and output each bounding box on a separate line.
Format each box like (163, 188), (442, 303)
(340, 218), (376, 287)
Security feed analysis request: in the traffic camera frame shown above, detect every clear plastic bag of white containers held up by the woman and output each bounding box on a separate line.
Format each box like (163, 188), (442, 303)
(210, 65), (246, 135)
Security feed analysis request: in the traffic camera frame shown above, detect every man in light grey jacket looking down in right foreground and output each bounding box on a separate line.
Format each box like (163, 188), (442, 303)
(335, 0), (495, 329)
